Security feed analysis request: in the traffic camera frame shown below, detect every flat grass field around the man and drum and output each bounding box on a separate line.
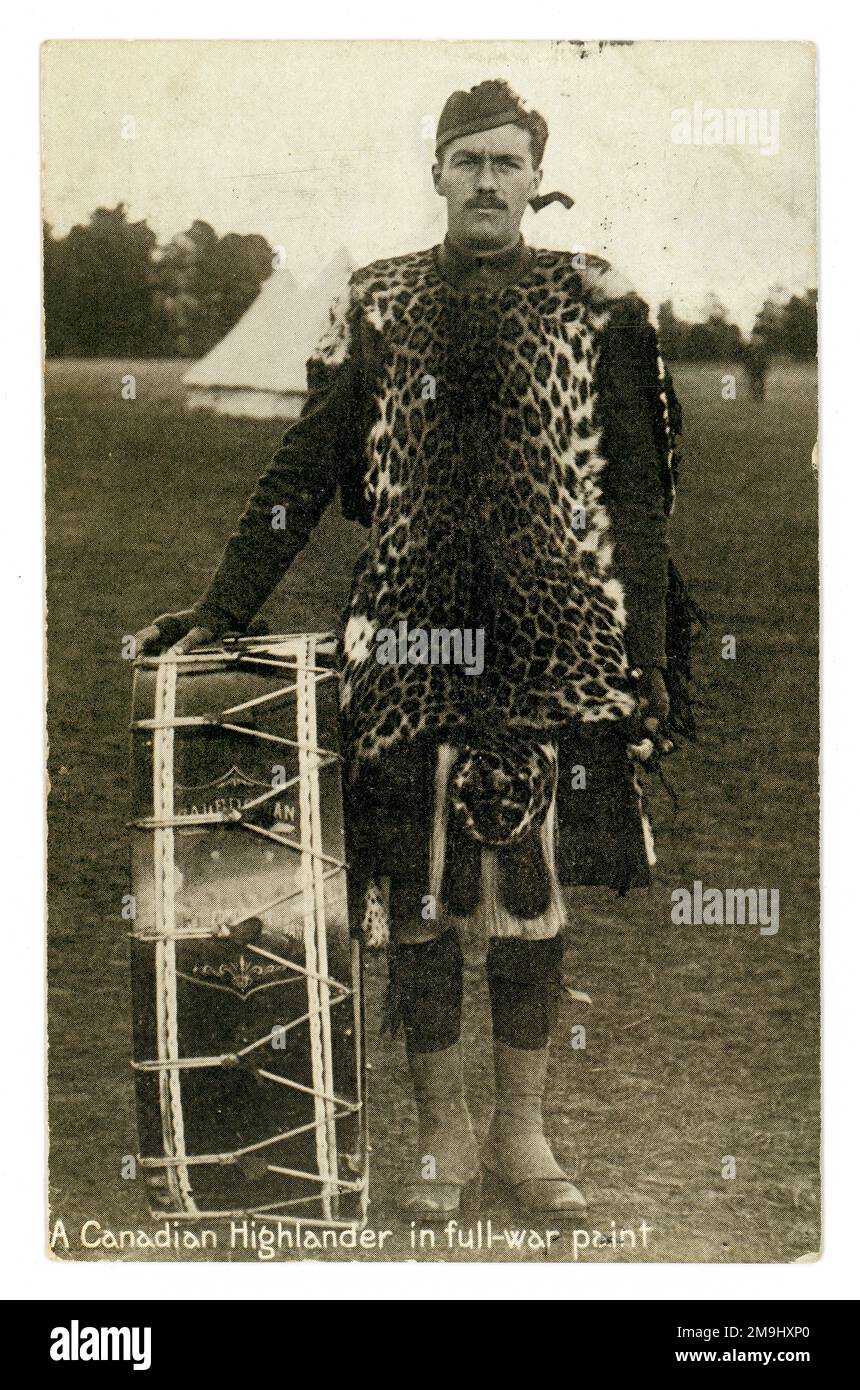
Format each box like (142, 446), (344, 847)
(47, 361), (818, 1262)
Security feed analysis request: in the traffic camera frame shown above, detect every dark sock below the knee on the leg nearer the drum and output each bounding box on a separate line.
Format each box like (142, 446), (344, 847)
(389, 930), (463, 1052)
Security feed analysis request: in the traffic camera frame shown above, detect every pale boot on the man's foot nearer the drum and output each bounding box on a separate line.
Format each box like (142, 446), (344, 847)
(402, 1043), (479, 1220)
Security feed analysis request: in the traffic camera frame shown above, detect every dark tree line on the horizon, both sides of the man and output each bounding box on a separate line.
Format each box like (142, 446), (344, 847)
(44, 203), (817, 361)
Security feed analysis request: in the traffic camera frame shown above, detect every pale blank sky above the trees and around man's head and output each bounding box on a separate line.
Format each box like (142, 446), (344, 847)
(43, 40), (817, 331)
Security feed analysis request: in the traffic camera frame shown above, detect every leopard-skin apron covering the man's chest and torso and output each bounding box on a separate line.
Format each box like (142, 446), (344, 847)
(315, 252), (650, 762)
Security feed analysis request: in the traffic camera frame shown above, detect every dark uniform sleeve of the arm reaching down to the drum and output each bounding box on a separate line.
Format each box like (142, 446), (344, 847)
(195, 279), (363, 634)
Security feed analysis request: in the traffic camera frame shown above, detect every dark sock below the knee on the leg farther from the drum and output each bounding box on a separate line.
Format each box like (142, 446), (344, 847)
(486, 937), (564, 1051)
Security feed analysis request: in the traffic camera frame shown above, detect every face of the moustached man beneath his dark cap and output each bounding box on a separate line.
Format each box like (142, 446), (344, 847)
(433, 125), (540, 250)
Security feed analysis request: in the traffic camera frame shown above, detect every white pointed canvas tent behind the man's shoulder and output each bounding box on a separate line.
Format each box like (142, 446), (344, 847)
(182, 247), (353, 420)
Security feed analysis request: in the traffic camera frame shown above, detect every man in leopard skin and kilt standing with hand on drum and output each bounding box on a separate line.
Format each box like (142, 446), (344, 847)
(139, 81), (678, 1219)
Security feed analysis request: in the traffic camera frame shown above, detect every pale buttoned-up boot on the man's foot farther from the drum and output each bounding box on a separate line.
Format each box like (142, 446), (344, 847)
(482, 1040), (586, 1216)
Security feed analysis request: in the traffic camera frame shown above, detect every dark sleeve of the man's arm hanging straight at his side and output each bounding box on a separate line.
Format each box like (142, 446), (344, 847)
(597, 295), (679, 669)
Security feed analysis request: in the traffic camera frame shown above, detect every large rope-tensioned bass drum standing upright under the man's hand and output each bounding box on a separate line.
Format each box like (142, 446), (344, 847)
(132, 634), (368, 1225)
